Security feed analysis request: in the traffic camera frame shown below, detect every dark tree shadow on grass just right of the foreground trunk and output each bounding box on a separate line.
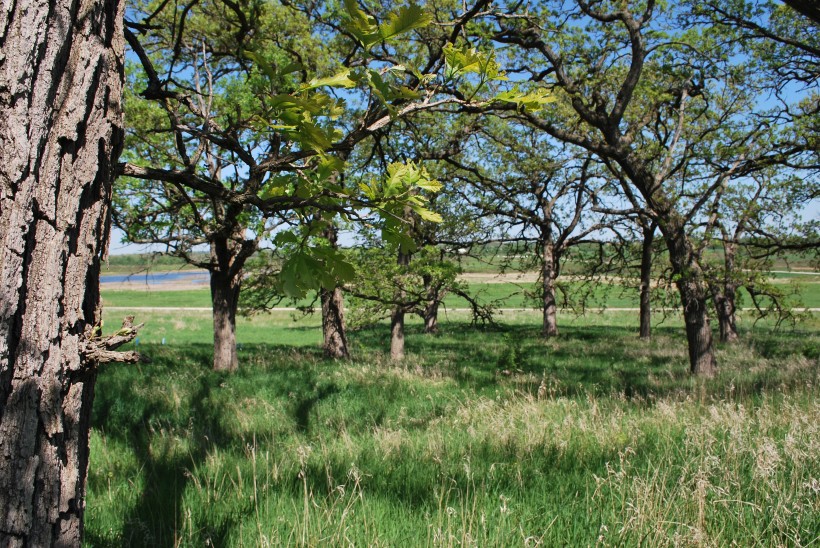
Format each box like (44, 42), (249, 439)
(85, 344), (350, 547)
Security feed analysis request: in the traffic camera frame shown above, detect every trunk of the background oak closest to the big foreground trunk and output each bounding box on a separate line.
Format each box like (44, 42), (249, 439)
(211, 238), (242, 371)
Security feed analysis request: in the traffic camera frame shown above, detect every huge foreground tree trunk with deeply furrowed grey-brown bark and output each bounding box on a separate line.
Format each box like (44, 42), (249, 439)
(0, 0), (123, 546)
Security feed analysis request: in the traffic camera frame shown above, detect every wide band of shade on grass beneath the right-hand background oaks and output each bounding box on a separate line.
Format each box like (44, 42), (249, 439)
(342, 322), (820, 400)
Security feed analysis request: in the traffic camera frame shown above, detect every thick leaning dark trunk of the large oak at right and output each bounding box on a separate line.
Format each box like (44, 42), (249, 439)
(661, 230), (717, 377)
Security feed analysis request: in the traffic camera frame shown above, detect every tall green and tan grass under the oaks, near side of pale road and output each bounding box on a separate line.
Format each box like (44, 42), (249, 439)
(85, 311), (820, 546)
